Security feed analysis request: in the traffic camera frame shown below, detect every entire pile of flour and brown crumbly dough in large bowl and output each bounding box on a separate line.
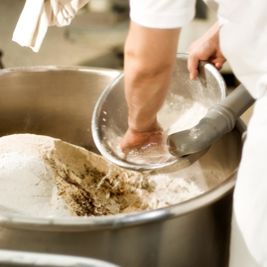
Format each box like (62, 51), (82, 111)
(0, 134), (206, 217)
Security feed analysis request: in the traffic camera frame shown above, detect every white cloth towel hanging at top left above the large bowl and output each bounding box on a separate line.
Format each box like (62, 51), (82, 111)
(12, 0), (89, 52)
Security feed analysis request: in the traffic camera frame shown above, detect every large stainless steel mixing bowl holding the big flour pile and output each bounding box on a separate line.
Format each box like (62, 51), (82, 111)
(0, 67), (242, 267)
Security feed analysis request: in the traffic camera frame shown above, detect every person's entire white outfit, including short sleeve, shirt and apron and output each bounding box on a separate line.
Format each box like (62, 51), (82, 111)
(130, 0), (267, 267)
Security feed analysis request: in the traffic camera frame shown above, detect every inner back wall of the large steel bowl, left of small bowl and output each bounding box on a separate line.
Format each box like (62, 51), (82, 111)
(0, 66), (120, 151)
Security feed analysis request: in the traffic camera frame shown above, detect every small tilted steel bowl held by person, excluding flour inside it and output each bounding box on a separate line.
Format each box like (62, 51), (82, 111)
(92, 54), (226, 170)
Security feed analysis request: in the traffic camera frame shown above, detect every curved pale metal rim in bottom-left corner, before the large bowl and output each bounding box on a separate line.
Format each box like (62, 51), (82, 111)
(0, 249), (119, 267)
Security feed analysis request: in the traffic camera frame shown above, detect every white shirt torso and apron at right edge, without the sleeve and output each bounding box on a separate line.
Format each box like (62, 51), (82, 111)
(219, 0), (267, 267)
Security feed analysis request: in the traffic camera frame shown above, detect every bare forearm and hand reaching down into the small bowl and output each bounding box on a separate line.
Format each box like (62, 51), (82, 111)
(121, 22), (180, 151)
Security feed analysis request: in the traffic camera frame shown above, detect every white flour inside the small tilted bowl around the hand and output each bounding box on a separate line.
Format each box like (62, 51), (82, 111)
(103, 96), (208, 164)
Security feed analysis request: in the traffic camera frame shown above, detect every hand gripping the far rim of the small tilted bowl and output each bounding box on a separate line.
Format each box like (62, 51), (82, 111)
(188, 23), (225, 79)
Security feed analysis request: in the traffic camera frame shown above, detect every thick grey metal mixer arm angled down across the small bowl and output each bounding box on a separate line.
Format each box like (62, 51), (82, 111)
(167, 84), (255, 160)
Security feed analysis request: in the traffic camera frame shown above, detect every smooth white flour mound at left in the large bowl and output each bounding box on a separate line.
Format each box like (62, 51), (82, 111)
(0, 135), (70, 217)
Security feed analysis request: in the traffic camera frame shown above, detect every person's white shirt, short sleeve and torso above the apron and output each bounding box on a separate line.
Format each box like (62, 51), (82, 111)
(130, 0), (267, 98)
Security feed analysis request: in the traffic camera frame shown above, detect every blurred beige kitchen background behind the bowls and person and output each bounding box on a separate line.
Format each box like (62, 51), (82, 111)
(0, 0), (251, 121)
